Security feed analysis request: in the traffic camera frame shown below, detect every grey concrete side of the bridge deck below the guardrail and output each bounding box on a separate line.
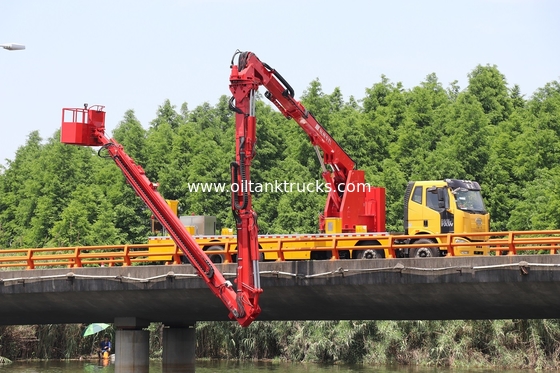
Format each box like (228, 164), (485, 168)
(0, 255), (560, 326)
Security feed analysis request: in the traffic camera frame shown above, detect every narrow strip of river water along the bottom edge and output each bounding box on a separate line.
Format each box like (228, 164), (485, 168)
(0, 360), (523, 373)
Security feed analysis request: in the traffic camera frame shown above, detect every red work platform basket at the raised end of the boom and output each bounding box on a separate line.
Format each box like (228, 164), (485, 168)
(60, 105), (105, 146)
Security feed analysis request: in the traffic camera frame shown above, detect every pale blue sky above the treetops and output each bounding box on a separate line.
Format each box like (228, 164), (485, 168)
(0, 0), (560, 164)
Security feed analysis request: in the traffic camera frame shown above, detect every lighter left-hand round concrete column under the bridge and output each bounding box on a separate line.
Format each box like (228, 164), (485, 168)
(114, 317), (150, 373)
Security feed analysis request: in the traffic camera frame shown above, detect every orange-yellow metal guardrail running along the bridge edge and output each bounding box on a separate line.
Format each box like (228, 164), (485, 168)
(0, 230), (560, 269)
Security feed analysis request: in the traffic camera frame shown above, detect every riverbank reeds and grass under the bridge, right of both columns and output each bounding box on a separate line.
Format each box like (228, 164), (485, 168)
(197, 320), (560, 369)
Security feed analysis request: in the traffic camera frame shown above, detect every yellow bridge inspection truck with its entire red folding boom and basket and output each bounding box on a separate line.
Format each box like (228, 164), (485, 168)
(61, 51), (488, 326)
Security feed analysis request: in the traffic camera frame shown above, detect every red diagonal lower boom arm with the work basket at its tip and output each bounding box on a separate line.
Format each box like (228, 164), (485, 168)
(61, 105), (262, 326)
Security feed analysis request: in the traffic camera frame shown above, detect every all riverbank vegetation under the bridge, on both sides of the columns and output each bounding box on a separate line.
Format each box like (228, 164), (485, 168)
(0, 320), (560, 369)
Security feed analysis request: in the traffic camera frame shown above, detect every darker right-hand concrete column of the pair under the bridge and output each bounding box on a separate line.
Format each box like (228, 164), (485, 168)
(162, 325), (196, 372)
